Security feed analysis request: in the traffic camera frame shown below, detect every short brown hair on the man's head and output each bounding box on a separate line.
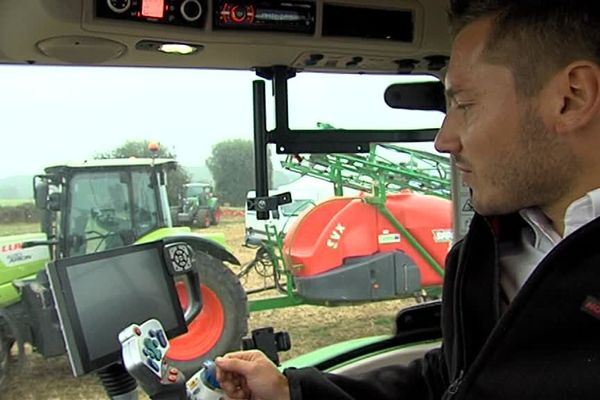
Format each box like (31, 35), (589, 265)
(449, 0), (600, 96)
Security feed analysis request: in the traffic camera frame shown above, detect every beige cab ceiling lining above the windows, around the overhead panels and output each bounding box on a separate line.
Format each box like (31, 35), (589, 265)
(0, 0), (450, 75)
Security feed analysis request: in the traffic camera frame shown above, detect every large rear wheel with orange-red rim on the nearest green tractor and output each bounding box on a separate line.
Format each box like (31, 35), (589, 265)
(167, 256), (248, 377)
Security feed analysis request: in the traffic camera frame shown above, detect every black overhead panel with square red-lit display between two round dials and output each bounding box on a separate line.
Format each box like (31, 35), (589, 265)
(96, 0), (208, 28)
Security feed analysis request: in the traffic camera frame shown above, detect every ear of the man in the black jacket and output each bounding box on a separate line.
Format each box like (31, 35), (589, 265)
(554, 61), (600, 134)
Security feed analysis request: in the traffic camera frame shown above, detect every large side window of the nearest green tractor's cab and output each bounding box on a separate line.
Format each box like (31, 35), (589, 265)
(65, 172), (158, 256)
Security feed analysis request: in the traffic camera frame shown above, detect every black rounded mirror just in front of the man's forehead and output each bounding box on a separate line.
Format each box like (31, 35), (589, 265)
(384, 81), (446, 113)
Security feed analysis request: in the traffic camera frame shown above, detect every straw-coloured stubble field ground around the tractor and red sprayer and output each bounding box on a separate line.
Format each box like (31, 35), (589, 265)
(0, 215), (414, 400)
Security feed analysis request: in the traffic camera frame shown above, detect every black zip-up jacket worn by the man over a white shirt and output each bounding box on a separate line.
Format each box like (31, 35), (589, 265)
(285, 216), (600, 400)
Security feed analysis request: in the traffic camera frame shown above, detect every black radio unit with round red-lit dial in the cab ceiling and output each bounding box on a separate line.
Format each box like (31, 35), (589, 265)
(213, 0), (315, 34)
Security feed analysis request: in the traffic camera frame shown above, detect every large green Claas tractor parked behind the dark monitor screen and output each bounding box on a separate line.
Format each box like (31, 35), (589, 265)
(0, 159), (248, 380)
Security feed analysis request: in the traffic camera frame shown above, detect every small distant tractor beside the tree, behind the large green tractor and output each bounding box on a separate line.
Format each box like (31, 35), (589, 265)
(173, 182), (221, 228)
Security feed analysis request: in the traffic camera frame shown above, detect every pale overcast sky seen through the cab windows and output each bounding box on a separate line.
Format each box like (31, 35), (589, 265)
(0, 66), (443, 179)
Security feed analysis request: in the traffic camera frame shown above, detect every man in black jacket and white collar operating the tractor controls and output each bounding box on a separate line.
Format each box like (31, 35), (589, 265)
(217, 0), (600, 400)
